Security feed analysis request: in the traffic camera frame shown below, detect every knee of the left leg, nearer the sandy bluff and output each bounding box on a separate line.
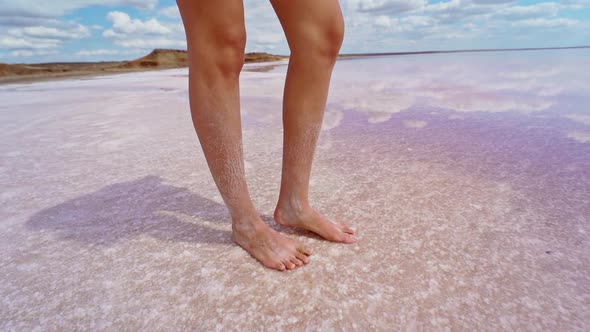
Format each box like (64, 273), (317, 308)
(191, 26), (246, 77)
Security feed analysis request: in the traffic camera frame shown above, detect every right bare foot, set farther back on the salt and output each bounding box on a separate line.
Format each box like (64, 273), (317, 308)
(274, 201), (356, 243)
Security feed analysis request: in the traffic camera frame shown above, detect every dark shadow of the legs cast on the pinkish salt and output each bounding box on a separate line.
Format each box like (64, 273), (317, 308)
(26, 175), (318, 246)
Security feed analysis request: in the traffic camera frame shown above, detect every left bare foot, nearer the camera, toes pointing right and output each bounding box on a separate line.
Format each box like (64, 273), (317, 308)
(232, 220), (311, 271)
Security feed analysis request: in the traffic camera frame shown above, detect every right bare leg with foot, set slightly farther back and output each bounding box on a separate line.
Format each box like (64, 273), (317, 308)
(271, 0), (356, 243)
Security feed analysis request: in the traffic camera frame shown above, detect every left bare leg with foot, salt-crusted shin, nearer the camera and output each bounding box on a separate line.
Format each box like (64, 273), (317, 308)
(177, 0), (311, 270)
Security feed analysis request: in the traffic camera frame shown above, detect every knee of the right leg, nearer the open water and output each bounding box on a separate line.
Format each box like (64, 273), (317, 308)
(291, 15), (344, 62)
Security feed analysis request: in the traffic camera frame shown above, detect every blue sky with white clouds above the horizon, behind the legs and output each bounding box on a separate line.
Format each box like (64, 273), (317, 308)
(0, 0), (590, 63)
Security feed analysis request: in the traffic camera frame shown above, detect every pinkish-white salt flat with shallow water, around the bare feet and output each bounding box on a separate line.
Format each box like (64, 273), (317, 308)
(0, 50), (590, 331)
